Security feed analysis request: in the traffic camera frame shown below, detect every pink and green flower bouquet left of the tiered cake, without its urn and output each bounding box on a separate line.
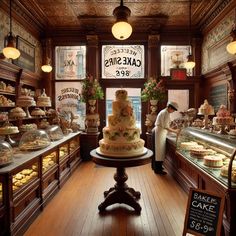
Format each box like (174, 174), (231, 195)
(80, 76), (104, 102)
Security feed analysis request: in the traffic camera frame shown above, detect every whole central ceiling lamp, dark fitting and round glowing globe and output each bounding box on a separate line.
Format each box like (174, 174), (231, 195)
(111, 0), (132, 40)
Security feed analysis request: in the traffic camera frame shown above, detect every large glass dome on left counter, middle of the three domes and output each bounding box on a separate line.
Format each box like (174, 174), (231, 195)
(19, 129), (51, 151)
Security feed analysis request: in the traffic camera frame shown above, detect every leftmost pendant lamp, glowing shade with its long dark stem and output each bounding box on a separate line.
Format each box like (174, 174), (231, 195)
(2, 0), (20, 60)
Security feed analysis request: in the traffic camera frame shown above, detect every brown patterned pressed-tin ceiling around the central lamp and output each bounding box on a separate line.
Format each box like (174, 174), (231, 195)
(6, 0), (235, 31)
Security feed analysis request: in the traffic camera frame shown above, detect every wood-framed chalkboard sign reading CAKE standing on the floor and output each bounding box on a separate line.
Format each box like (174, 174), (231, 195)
(183, 188), (224, 236)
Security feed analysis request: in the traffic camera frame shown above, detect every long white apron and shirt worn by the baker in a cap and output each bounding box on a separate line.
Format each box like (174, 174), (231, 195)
(155, 108), (170, 161)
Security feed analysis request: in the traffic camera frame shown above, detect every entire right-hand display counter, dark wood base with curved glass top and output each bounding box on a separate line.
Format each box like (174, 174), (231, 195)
(164, 127), (236, 236)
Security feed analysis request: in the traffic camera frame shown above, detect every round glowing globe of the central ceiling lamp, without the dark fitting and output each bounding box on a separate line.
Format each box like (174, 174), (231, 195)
(111, 21), (132, 40)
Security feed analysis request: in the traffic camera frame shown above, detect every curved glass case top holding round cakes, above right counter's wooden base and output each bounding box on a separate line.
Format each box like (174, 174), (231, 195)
(176, 127), (236, 188)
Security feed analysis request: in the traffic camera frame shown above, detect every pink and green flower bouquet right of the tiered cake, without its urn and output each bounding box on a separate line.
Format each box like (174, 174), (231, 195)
(141, 78), (166, 102)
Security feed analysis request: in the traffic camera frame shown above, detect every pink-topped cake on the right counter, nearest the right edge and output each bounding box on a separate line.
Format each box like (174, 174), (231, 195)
(213, 105), (234, 125)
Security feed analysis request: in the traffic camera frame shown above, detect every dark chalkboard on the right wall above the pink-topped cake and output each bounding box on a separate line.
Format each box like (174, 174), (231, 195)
(209, 84), (228, 112)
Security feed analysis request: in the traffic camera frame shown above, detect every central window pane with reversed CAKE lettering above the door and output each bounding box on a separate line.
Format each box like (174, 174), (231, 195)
(102, 45), (144, 79)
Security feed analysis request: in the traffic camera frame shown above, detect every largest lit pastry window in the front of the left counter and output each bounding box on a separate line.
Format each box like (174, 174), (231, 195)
(12, 162), (38, 193)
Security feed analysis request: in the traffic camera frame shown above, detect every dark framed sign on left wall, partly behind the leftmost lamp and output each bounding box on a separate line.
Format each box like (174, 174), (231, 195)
(13, 36), (35, 72)
